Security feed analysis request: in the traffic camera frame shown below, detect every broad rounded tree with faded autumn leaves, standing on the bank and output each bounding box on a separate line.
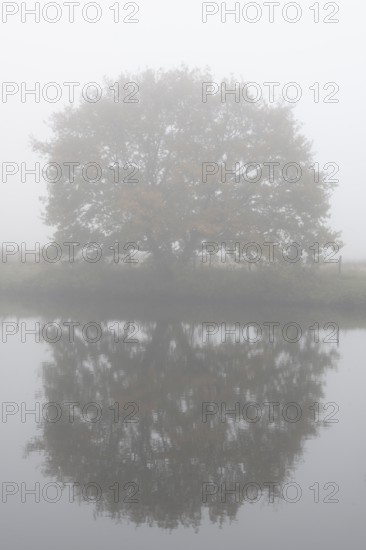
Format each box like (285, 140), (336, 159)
(34, 67), (337, 269)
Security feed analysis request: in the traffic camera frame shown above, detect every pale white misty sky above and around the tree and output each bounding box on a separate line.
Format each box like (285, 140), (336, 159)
(0, 0), (366, 259)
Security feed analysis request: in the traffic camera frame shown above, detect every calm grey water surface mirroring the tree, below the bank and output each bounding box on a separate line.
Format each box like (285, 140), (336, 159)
(0, 305), (366, 550)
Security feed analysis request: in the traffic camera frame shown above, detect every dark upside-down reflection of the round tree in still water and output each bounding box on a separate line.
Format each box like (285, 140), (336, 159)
(28, 321), (337, 528)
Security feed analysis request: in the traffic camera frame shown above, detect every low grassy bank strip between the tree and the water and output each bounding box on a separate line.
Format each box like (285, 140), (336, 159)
(0, 263), (366, 308)
